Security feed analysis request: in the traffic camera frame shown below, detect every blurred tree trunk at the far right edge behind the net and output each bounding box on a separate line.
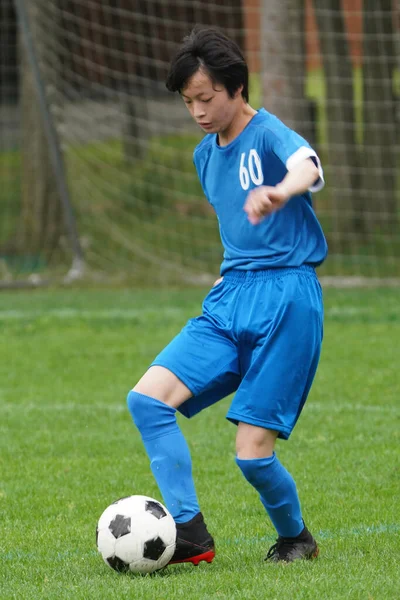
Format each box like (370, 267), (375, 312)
(362, 0), (399, 230)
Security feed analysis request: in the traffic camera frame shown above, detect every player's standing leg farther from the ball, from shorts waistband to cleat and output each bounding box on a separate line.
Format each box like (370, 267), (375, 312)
(227, 270), (322, 562)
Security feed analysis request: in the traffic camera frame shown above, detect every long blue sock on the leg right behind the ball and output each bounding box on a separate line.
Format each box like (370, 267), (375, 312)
(127, 391), (200, 523)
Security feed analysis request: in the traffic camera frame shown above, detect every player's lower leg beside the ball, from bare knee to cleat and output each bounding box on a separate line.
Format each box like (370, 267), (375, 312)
(127, 367), (215, 564)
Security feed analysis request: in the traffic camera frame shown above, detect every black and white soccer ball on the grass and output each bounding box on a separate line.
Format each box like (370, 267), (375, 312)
(96, 496), (176, 573)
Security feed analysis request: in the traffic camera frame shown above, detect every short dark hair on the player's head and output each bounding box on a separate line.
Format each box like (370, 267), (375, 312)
(166, 26), (249, 102)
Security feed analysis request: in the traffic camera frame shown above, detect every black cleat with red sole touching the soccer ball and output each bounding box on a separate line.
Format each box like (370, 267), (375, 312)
(168, 513), (215, 565)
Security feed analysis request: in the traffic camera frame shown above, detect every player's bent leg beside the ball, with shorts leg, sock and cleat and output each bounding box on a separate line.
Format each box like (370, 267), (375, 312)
(127, 289), (240, 563)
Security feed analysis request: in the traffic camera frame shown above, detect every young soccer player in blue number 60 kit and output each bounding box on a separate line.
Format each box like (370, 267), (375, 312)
(127, 28), (327, 564)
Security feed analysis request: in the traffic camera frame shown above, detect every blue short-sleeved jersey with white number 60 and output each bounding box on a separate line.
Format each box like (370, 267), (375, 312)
(194, 109), (327, 275)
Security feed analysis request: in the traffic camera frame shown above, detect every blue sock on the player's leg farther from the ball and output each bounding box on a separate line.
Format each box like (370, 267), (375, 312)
(236, 453), (304, 537)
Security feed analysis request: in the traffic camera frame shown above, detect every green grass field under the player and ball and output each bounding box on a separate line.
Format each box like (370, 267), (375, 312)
(0, 289), (400, 600)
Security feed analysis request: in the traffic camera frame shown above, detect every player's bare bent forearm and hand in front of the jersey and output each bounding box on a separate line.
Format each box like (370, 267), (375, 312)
(244, 158), (320, 225)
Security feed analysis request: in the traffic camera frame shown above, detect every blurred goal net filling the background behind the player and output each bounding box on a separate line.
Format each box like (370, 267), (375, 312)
(0, 0), (400, 284)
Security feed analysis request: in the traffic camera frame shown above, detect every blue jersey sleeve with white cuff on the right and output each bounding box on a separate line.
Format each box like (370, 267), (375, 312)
(270, 126), (325, 192)
